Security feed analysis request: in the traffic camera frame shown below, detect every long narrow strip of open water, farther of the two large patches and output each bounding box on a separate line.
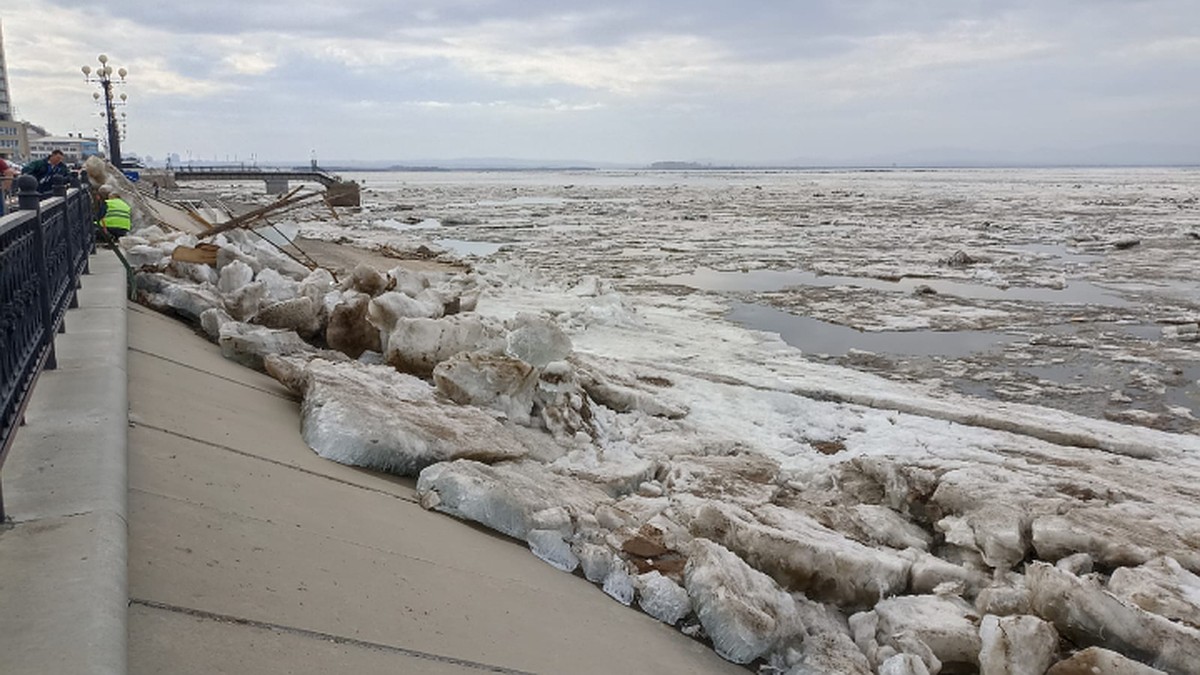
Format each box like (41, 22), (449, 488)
(662, 268), (1129, 307)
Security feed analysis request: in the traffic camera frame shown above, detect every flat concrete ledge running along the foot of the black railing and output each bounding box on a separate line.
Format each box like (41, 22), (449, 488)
(0, 250), (128, 675)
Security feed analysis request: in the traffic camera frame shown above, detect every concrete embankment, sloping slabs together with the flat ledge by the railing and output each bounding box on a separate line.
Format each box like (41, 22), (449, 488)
(0, 251), (745, 675)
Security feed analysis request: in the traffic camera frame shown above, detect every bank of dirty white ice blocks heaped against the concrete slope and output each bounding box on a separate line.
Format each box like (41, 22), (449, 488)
(121, 218), (1200, 674)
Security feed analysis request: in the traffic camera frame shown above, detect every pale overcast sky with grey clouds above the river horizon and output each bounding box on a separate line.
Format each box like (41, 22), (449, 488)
(0, 0), (1200, 165)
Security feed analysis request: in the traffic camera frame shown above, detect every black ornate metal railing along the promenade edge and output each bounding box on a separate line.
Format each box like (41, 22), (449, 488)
(0, 175), (95, 522)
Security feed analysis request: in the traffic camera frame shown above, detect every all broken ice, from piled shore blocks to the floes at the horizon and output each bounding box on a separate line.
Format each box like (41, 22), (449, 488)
(139, 172), (1200, 674)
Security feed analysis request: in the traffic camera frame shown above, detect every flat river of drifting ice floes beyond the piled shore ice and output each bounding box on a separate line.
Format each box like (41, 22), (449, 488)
(336, 168), (1200, 432)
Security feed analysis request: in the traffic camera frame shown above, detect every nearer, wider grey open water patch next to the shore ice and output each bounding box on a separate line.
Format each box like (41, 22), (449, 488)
(726, 301), (1013, 358)
